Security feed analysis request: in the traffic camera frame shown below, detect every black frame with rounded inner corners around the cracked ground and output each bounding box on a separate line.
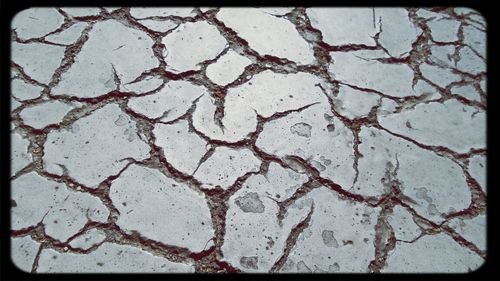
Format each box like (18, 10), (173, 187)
(0, 0), (500, 280)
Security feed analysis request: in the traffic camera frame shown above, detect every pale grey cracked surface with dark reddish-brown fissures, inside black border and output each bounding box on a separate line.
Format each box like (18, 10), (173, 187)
(10, 7), (487, 273)
